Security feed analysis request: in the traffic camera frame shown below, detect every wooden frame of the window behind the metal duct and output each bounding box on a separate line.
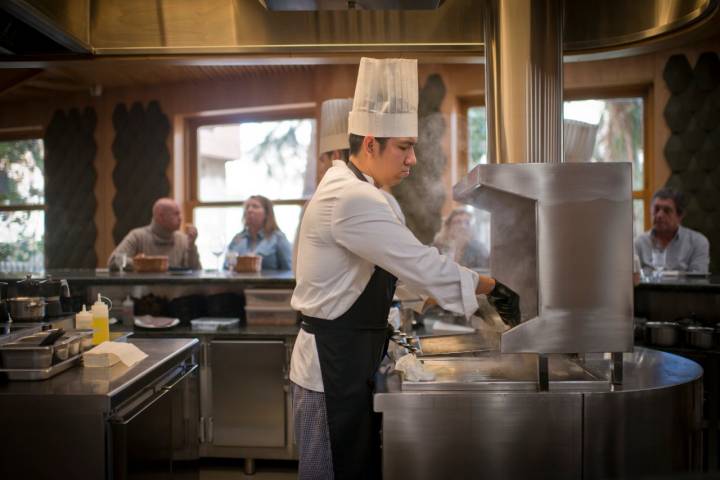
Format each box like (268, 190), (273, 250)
(458, 84), (655, 230)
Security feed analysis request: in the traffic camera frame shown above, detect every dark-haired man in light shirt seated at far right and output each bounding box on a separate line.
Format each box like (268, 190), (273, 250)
(635, 188), (710, 273)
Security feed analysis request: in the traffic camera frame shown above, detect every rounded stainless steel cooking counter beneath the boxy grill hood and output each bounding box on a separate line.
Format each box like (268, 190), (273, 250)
(374, 348), (703, 479)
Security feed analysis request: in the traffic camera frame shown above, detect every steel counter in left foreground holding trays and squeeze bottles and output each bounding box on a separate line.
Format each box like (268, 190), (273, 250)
(0, 338), (199, 480)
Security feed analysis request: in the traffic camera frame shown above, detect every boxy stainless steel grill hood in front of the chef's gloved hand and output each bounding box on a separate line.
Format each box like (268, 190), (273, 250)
(454, 163), (633, 353)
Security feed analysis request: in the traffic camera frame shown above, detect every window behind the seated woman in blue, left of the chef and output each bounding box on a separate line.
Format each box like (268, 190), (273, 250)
(191, 110), (315, 268)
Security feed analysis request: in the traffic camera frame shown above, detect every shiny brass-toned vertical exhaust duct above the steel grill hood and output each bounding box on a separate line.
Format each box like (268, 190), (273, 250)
(483, 0), (564, 163)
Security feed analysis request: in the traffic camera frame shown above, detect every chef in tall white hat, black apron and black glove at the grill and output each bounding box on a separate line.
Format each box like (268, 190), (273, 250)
(290, 58), (520, 479)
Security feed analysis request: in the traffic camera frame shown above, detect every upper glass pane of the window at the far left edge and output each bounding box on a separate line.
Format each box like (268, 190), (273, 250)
(0, 138), (45, 205)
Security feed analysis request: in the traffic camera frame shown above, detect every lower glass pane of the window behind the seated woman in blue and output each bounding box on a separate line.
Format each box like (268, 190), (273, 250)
(193, 205), (302, 266)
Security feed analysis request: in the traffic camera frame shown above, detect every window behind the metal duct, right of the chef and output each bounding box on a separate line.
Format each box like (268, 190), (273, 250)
(464, 94), (652, 235)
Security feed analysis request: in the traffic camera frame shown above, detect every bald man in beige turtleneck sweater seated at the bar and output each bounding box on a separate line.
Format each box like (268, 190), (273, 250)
(108, 198), (202, 270)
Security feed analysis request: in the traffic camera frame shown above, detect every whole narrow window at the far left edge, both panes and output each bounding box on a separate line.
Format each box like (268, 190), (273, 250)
(0, 136), (45, 272)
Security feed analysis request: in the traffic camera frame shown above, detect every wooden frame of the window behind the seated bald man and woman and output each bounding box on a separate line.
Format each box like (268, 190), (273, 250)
(184, 104), (317, 221)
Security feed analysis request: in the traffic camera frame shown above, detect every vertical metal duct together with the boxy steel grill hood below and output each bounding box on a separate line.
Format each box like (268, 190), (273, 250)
(454, 0), (633, 354)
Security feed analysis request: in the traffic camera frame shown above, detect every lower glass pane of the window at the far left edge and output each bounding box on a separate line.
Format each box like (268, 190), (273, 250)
(0, 210), (45, 272)
